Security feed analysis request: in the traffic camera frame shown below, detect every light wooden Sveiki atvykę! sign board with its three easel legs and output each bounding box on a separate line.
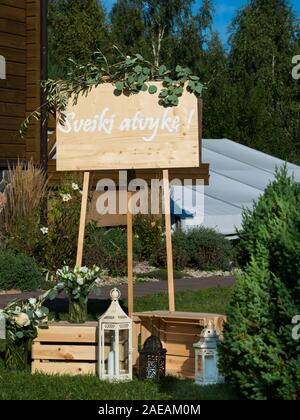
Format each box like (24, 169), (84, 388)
(56, 82), (203, 316)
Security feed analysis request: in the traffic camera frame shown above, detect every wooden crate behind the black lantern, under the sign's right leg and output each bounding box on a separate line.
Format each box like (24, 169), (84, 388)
(132, 311), (225, 378)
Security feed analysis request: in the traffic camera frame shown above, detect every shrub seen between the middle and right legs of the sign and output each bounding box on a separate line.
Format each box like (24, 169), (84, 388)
(134, 214), (162, 261)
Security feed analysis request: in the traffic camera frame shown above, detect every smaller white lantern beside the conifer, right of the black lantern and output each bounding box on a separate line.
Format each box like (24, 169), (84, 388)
(194, 321), (224, 385)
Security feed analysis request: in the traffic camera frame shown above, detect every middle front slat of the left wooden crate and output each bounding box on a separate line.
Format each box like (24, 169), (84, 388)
(32, 342), (97, 361)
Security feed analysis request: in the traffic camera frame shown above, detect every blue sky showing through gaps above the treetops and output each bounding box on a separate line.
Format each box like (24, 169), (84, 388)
(102, 0), (300, 45)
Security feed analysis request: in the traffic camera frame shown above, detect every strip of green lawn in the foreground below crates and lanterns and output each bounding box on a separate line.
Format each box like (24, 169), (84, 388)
(0, 363), (237, 401)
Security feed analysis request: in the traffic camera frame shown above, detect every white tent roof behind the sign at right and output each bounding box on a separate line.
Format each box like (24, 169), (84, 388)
(173, 139), (300, 235)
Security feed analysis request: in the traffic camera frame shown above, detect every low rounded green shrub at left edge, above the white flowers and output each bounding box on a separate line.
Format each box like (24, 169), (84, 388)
(0, 250), (43, 291)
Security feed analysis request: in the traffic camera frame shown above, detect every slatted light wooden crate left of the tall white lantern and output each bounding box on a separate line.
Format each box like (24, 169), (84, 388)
(32, 322), (98, 375)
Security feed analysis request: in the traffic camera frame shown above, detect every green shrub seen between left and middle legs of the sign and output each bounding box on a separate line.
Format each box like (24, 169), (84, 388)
(84, 223), (140, 276)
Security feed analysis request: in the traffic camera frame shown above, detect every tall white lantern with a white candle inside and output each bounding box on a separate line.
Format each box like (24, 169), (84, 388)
(98, 288), (132, 381)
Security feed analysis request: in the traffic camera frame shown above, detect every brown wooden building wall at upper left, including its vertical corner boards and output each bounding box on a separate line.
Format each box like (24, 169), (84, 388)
(0, 0), (40, 163)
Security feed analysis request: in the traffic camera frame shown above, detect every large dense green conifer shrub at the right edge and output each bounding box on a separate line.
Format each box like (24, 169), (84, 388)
(220, 169), (300, 400)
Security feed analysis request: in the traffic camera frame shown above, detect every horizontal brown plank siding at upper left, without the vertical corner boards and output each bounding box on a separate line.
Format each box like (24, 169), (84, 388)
(0, 0), (26, 160)
